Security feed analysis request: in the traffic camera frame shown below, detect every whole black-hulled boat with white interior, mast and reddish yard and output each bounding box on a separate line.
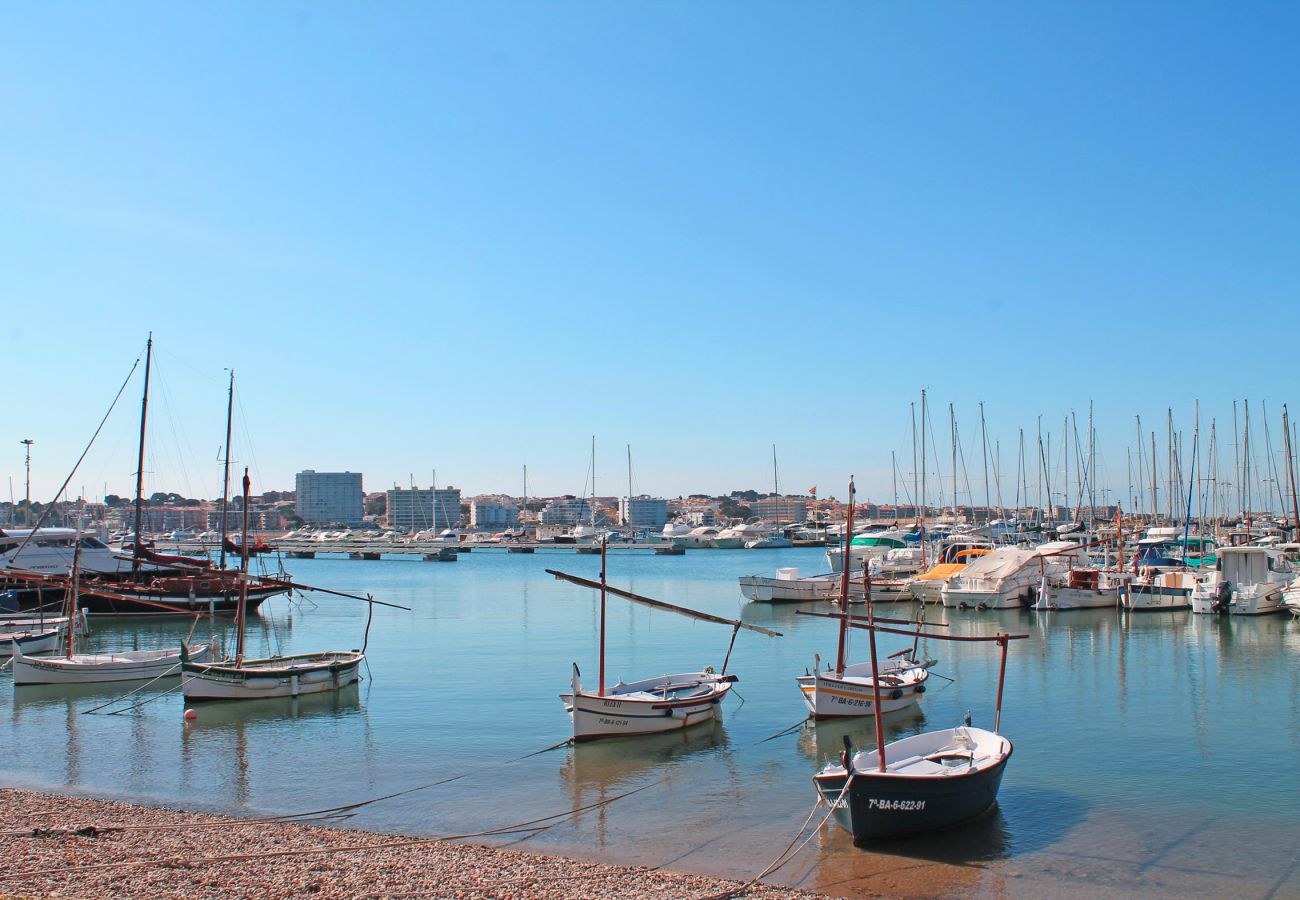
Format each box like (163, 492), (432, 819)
(813, 548), (1027, 845)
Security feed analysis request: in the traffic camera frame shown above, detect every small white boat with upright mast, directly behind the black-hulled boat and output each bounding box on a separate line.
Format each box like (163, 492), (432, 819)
(796, 481), (930, 719)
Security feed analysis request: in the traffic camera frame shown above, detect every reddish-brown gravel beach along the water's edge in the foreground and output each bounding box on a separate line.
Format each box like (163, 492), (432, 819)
(0, 788), (814, 900)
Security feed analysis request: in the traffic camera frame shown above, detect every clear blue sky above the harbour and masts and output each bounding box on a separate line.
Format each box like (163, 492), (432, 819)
(0, 0), (1300, 501)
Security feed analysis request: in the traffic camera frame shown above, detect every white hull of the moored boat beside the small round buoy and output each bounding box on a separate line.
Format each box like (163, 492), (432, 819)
(181, 652), (365, 700)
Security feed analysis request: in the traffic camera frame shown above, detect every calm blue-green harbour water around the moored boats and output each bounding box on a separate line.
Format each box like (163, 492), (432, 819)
(0, 549), (1300, 896)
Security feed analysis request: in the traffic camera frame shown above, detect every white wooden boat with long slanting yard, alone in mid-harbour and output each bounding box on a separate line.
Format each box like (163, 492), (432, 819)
(546, 541), (781, 741)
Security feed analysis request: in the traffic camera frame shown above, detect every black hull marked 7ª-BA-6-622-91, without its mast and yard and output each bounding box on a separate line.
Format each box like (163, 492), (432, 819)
(813, 733), (1011, 845)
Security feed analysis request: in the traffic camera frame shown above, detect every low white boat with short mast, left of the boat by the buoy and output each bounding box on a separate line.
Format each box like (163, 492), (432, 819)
(13, 520), (212, 684)
